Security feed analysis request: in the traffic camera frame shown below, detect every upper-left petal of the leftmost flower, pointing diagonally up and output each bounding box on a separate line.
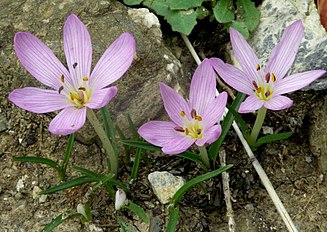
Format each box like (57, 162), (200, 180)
(14, 32), (69, 90)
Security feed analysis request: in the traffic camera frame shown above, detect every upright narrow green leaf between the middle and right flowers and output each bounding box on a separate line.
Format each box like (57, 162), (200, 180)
(209, 93), (245, 163)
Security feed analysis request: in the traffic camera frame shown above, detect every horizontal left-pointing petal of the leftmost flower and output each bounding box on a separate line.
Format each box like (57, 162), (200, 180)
(8, 87), (70, 113)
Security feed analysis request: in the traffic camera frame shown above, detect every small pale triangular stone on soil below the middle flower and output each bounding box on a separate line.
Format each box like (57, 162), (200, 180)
(148, 172), (185, 204)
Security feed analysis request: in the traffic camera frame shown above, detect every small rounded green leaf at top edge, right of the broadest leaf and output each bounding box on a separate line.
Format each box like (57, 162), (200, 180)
(213, 0), (235, 23)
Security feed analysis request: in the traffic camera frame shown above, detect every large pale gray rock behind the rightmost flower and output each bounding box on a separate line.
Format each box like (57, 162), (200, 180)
(232, 0), (327, 90)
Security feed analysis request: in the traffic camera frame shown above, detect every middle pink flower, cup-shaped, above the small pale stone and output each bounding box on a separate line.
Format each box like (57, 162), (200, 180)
(138, 60), (227, 154)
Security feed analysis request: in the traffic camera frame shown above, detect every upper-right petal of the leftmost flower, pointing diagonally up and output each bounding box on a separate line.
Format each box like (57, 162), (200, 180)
(90, 32), (136, 89)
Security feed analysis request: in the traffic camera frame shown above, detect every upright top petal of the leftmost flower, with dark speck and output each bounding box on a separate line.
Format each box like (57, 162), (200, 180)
(64, 14), (92, 88)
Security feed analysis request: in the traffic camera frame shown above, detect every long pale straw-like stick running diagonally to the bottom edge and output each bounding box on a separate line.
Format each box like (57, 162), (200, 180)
(181, 34), (298, 232)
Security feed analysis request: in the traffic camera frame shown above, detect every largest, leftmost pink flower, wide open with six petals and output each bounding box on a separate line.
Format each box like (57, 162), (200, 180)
(9, 14), (135, 135)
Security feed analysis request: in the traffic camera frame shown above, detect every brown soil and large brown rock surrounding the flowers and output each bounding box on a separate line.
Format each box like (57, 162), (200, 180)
(0, 1), (327, 232)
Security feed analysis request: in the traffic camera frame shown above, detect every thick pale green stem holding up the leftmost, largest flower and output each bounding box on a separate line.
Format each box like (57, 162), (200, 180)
(87, 109), (119, 176)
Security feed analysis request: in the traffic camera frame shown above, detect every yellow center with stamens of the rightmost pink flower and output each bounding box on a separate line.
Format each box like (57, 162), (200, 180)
(252, 70), (276, 102)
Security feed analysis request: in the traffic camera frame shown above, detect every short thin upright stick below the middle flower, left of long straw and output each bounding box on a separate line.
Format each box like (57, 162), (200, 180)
(219, 149), (236, 232)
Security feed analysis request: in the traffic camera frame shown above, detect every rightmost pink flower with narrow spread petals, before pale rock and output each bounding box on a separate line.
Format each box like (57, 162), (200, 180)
(210, 20), (326, 113)
